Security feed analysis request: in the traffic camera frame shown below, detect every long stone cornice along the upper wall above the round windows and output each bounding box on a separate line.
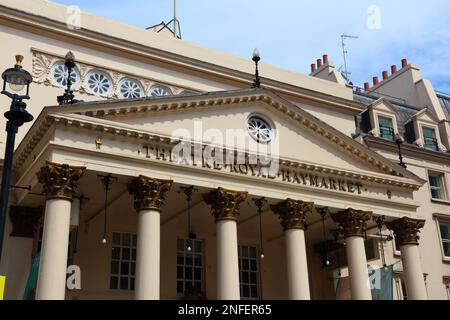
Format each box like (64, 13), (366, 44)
(0, 5), (364, 115)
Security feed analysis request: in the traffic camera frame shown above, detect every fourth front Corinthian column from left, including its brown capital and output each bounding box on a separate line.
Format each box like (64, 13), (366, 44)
(270, 199), (314, 300)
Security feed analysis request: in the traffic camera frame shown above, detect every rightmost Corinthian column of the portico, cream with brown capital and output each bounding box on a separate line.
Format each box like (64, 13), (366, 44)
(386, 217), (428, 300)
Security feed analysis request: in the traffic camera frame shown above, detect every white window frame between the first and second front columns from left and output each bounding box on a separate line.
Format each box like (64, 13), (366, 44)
(108, 231), (137, 292)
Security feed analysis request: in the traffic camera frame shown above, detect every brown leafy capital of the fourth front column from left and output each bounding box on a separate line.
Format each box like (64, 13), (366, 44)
(270, 199), (314, 231)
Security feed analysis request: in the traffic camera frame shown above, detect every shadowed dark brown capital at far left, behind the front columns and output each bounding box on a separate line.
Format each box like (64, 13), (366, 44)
(9, 206), (44, 239)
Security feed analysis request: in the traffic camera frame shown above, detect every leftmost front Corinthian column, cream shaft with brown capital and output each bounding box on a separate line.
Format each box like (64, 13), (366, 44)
(36, 162), (86, 300)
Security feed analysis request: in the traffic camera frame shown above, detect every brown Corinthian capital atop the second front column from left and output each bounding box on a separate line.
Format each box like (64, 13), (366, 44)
(128, 175), (173, 212)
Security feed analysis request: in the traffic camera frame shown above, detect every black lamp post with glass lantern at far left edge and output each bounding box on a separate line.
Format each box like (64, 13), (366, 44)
(0, 55), (33, 259)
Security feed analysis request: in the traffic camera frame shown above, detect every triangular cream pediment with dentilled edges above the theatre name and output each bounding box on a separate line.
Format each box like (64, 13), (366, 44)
(18, 89), (422, 184)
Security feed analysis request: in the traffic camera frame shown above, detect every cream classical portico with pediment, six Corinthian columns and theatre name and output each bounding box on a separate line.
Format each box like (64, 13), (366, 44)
(7, 90), (428, 300)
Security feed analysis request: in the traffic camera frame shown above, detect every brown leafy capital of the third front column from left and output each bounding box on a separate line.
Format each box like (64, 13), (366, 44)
(203, 188), (248, 222)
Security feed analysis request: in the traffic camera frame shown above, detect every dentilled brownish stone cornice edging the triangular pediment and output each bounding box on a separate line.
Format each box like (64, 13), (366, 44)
(15, 90), (422, 190)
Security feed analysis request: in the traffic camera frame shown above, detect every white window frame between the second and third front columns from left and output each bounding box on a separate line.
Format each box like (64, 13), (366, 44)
(175, 237), (206, 299)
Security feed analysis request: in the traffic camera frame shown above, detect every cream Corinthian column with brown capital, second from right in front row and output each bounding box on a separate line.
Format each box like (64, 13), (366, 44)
(331, 209), (372, 300)
